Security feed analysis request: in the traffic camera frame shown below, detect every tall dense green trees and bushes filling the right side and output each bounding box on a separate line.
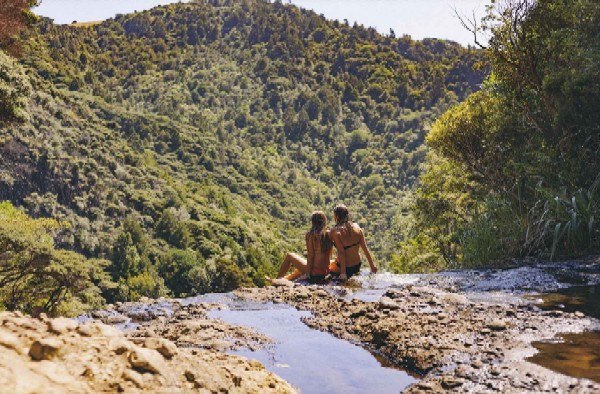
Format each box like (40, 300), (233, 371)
(393, 0), (600, 270)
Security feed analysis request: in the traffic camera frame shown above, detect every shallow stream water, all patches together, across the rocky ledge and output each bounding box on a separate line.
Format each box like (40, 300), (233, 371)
(107, 262), (600, 393)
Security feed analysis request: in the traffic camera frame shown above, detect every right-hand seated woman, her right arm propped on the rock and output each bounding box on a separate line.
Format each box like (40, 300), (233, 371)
(329, 204), (377, 281)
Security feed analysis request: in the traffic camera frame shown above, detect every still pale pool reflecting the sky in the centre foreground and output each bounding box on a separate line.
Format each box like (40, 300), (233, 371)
(210, 299), (417, 394)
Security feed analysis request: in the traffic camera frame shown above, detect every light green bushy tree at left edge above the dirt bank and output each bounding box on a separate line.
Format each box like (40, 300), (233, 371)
(0, 201), (112, 315)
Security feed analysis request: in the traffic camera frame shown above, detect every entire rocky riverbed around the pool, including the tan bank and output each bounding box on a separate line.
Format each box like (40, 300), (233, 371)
(0, 261), (600, 393)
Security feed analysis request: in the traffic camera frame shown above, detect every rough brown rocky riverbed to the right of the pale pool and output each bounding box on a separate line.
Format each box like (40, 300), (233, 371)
(236, 282), (600, 393)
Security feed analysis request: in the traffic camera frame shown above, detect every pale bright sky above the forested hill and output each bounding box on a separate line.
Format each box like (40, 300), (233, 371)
(35, 0), (489, 46)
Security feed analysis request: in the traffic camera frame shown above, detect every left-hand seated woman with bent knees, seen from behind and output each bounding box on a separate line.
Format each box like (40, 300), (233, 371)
(265, 211), (333, 282)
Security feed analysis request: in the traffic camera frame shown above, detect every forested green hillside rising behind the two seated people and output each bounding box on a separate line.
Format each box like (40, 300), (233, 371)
(0, 0), (485, 314)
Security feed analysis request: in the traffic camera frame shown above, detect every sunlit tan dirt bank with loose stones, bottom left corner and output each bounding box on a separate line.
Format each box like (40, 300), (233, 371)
(0, 312), (295, 393)
